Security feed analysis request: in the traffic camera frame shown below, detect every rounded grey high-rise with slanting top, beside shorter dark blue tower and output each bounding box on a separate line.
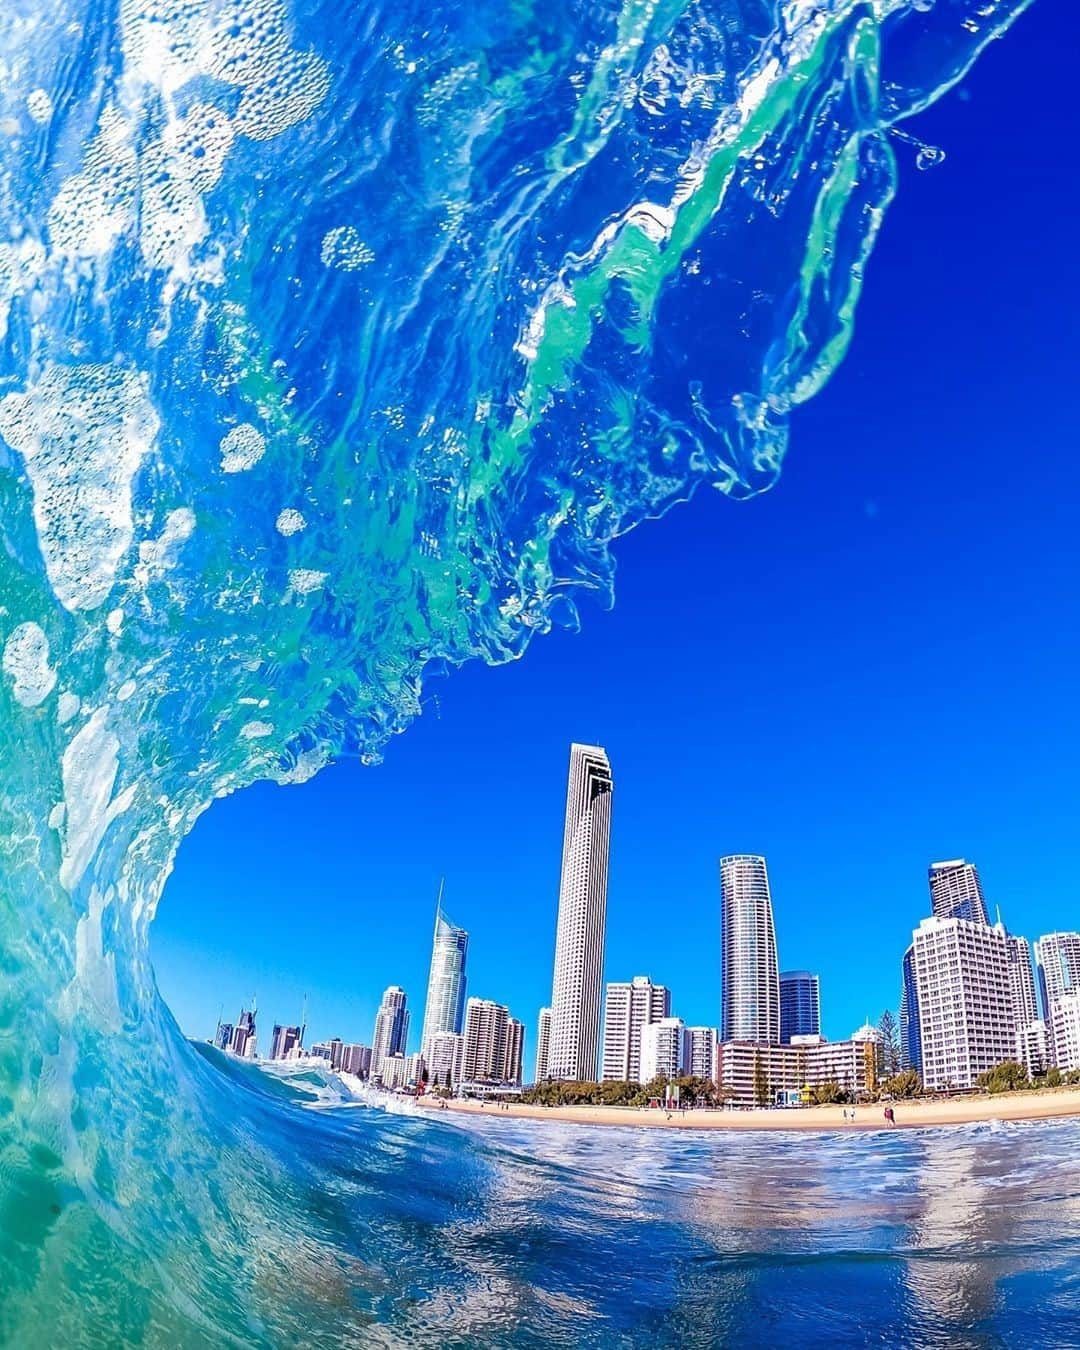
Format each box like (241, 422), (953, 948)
(720, 853), (780, 1045)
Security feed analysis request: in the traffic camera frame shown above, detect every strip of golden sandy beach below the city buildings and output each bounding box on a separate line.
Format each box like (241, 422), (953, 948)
(417, 1088), (1080, 1131)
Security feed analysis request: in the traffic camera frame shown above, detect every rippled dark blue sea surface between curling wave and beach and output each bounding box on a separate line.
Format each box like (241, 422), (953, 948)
(162, 1050), (1080, 1347)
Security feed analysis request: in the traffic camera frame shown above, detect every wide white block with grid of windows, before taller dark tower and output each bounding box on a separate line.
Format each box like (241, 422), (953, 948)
(913, 917), (1017, 1091)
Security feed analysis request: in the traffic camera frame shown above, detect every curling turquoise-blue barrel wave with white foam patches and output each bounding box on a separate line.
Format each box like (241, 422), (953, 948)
(0, 0), (1025, 1346)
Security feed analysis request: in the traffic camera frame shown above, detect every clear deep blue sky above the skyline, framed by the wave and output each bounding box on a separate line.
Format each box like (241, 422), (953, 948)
(154, 0), (1080, 1064)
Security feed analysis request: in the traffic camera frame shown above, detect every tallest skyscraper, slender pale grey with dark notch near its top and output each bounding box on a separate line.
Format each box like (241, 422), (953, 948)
(547, 744), (612, 1081)
